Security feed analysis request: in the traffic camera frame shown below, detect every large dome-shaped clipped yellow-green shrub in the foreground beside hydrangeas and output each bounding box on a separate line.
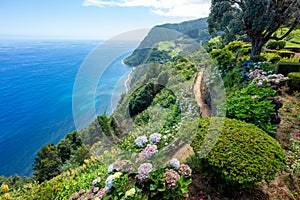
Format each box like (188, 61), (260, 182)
(191, 118), (285, 188)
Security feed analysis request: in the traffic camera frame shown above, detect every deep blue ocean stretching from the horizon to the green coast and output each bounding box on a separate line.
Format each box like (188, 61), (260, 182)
(0, 40), (135, 176)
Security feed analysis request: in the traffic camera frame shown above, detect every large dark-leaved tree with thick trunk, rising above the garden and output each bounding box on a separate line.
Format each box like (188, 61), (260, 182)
(207, 0), (300, 56)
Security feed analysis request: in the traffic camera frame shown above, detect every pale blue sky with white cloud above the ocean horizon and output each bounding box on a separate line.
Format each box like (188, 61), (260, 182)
(0, 0), (210, 39)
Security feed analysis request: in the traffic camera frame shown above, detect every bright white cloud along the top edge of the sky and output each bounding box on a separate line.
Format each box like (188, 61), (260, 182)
(83, 0), (211, 17)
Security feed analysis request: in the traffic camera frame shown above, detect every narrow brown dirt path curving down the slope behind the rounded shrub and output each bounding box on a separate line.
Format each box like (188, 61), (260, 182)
(194, 72), (211, 117)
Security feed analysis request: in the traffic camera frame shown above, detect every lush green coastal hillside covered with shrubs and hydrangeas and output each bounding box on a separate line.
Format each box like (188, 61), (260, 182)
(0, 1), (300, 199)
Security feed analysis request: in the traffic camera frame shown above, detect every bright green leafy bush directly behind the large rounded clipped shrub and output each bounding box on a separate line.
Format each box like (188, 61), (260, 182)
(218, 85), (276, 135)
